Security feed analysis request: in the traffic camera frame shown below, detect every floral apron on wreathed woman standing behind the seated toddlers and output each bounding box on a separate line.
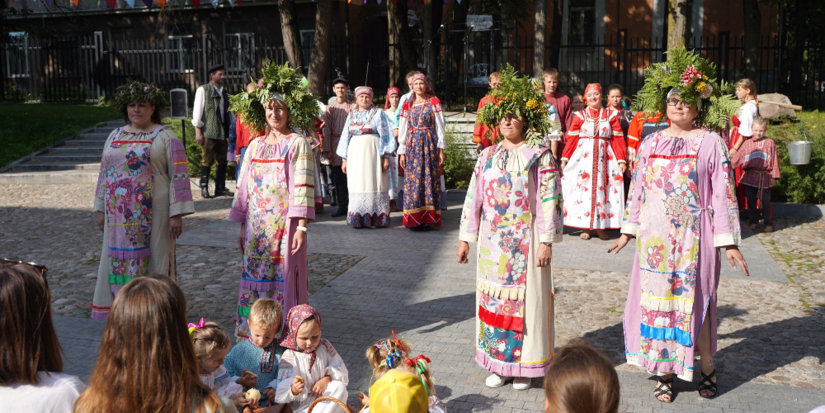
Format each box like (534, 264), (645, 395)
(236, 146), (290, 337)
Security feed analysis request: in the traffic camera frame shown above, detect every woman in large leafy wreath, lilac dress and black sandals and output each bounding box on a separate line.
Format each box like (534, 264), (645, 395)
(609, 47), (748, 402)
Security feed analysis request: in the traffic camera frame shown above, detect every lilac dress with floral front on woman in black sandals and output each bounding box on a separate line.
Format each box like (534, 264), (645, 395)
(622, 131), (741, 381)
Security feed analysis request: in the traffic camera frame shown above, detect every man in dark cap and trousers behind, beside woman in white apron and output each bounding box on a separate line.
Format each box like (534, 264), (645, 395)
(321, 78), (355, 217)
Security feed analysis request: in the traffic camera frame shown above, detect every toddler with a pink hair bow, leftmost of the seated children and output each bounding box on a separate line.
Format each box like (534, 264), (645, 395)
(189, 318), (248, 407)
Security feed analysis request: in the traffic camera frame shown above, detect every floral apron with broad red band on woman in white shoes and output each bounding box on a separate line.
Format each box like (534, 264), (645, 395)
(477, 148), (547, 363)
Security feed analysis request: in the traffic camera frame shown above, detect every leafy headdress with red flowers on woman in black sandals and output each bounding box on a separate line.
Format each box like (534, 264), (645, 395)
(633, 46), (740, 129)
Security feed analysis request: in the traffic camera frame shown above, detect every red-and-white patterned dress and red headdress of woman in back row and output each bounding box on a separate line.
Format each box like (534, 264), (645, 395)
(562, 84), (627, 230)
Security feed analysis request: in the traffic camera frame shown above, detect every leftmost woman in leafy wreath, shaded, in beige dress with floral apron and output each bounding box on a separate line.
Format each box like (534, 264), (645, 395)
(92, 80), (195, 320)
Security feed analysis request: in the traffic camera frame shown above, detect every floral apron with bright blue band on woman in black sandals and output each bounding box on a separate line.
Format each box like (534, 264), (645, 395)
(629, 135), (712, 365)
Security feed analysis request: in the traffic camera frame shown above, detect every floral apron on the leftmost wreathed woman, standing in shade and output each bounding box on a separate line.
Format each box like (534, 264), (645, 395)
(103, 129), (154, 297)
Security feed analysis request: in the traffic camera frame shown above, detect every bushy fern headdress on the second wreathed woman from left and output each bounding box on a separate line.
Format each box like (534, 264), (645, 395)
(229, 59), (320, 131)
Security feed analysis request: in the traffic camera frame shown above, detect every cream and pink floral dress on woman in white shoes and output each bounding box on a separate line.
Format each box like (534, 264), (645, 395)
(459, 144), (562, 377)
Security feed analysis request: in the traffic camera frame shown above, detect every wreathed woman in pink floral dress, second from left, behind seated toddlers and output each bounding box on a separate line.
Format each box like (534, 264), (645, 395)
(229, 61), (319, 338)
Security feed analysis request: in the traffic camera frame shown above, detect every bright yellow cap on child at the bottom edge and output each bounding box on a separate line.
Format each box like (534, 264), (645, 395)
(370, 370), (429, 413)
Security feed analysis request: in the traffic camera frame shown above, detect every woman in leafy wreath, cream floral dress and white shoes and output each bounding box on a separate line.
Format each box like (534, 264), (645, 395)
(457, 65), (562, 390)
